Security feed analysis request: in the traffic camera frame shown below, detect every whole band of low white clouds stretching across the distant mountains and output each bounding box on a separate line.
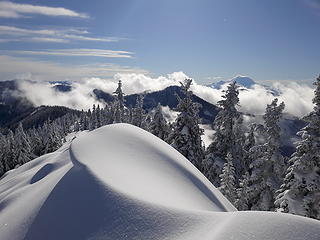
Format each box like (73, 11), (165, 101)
(15, 72), (313, 117)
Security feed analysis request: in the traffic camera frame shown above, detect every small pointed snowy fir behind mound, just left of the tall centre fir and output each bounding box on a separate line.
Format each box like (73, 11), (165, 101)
(149, 103), (170, 140)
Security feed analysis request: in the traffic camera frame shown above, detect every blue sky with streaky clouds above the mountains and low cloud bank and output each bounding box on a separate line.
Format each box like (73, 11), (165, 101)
(0, 0), (320, 84)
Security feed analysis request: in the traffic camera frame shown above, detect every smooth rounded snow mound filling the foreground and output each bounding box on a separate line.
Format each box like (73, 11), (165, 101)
(0, 124), (320, 240)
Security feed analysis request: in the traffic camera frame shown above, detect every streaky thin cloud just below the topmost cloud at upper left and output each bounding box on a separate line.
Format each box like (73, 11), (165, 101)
(0, 25), (120, 43)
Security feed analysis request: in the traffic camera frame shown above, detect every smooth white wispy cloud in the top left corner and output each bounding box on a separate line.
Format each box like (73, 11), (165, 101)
(0, 1), (89, 18)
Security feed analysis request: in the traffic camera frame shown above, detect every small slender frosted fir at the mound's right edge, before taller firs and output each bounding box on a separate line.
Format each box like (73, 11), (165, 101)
(219, 153), (237, 204)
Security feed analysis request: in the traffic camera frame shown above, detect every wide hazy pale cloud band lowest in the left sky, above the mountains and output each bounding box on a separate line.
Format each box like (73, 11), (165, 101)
(0, 55), (148, 81)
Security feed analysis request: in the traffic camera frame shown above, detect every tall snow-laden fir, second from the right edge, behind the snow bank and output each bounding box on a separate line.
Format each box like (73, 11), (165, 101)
(249, 99), (284, 211)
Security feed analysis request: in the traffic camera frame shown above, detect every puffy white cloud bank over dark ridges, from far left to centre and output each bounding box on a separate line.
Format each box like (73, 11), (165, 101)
(13, 71), (185, 110)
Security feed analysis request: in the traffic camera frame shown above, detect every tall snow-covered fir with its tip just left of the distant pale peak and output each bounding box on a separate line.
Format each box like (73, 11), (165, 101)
(203, 82), (245, 185)
